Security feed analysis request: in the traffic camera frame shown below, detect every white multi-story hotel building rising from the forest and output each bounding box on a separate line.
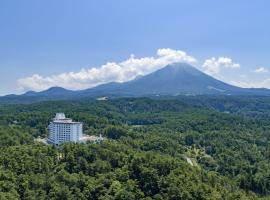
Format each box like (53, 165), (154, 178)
(48, 113), (83, 145)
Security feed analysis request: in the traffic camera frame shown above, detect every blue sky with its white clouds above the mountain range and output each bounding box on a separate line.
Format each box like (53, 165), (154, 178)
(0, 0), (270, 95)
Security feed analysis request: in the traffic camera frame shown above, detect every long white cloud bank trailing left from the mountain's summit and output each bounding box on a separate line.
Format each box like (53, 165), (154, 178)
(18, 48), (196, 91)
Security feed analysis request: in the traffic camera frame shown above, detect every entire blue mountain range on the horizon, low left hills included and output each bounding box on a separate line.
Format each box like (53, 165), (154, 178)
(0, 63), (270, 103)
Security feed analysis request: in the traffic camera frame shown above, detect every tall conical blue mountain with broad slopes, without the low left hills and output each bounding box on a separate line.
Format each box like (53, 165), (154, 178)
(83, 63), (270, 96)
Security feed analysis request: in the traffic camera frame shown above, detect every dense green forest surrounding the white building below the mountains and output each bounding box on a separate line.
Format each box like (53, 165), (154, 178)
(0, 96), (270, 200)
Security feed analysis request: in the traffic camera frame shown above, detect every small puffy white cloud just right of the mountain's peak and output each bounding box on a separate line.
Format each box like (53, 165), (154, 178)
(203, 57), (240, 75)
